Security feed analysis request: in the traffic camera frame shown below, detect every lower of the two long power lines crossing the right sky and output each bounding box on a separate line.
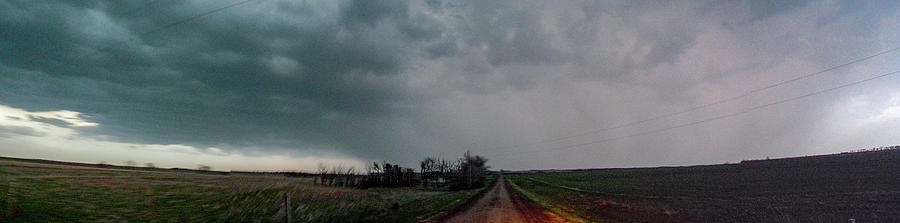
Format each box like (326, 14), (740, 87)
(507, 70), (900, 158)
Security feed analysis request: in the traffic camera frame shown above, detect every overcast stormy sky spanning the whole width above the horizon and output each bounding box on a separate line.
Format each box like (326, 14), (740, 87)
(0, 0), (900, 170)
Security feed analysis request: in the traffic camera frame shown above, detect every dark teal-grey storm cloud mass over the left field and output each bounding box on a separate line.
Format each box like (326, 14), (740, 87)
(0, 1), (440, 158)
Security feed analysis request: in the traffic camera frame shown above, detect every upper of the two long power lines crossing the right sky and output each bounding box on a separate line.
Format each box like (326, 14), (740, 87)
(482, 47), (900, 154)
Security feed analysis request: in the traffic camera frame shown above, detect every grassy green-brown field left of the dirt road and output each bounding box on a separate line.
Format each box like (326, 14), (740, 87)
(0, 159), (486, 222)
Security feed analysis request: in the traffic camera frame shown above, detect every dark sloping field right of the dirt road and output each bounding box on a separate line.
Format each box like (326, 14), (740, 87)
(507, 150), (900, 222)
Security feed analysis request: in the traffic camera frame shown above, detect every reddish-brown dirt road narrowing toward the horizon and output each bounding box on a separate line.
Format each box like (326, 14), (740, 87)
(442, 176), (567, 222)
